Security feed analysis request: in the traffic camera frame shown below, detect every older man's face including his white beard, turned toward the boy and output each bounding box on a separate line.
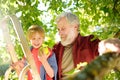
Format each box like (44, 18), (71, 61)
(57, 18), (77, 46)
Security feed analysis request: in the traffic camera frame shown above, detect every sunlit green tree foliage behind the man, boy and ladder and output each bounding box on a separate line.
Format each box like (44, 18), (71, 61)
(0, 0), (120, 79)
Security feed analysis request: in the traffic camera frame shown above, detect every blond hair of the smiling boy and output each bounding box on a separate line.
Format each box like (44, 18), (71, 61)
(27, 25), (45, 40)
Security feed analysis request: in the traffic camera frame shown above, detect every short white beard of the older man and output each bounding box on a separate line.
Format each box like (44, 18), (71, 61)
(61, 30), (76, 46)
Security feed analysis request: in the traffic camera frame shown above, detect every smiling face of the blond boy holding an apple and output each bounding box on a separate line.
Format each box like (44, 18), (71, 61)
(30, 32), (43, 48)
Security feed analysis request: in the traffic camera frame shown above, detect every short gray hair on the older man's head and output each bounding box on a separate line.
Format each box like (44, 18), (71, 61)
(56, 12), (80, 27)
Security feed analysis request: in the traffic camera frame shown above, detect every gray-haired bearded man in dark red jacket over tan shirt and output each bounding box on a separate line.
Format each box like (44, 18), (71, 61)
(53, 12), (99, 80)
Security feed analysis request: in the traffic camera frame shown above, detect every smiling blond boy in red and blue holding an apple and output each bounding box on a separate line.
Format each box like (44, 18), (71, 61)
(13, 25), (57, 80)
